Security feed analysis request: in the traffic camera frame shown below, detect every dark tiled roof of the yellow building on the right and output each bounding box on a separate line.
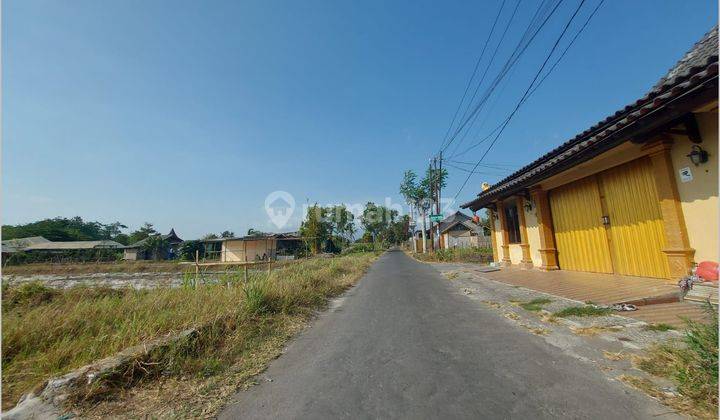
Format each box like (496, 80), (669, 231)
(461, 26), (718, 209)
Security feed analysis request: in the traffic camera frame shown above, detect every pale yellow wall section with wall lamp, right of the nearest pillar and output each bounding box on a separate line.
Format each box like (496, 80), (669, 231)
(671, 110), (719, 263)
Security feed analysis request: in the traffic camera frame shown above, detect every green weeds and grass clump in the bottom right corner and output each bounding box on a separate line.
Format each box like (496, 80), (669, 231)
(638, 303), (718, 418)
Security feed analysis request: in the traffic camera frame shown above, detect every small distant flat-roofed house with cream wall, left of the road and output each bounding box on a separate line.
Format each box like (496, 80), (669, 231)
(202, 232), (303, 262)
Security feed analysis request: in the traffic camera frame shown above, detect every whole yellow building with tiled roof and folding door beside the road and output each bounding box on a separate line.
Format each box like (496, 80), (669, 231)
(462, 27), (718, 279)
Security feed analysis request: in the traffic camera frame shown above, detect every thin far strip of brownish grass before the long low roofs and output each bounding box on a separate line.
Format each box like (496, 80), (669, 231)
(2, 261), (194, 276)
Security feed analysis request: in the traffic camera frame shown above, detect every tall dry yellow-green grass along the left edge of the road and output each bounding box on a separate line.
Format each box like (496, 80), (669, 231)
(2, 254), (375, 409)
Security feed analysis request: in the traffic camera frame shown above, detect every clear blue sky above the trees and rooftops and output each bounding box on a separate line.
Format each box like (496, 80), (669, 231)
(2, 0), (717, 238)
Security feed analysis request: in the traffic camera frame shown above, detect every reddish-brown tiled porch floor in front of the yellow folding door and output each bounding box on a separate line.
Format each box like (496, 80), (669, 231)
(482, 267), (707, 327)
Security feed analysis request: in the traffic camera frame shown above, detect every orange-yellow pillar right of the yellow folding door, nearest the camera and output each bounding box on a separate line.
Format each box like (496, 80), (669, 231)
(643, 137), (695, 280)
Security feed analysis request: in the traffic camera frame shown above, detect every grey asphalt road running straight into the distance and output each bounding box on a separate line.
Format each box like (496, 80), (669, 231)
(220, 251), (672, 419)
